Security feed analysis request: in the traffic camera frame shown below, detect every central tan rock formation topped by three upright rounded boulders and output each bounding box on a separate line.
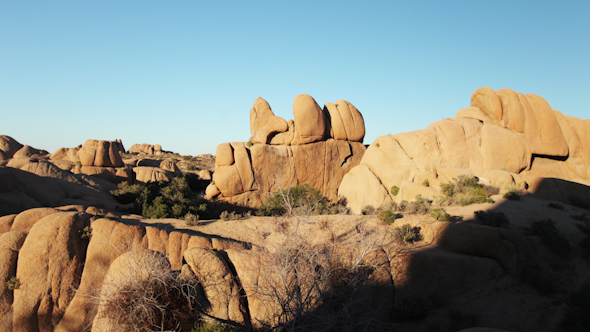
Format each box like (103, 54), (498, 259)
(206, 95), (365, 208)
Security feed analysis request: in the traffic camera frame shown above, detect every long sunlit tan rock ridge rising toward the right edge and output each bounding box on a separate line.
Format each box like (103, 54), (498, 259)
(338, 88), (590, 213)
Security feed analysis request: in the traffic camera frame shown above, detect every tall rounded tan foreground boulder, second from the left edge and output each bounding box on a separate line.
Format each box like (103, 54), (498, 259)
(12, 212), (90, 331)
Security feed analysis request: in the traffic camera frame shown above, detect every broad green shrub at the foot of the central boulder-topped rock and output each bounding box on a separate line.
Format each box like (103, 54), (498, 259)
(258, 183), (330, 216)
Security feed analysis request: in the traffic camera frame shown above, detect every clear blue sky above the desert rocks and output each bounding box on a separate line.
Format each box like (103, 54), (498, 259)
(0, 0), (590, 155)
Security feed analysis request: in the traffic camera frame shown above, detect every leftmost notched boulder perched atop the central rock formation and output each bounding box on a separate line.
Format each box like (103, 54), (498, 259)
(250, 97), (288, 144)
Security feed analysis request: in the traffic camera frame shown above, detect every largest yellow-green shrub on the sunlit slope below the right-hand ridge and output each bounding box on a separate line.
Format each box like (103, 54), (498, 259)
(436, 175), (494, 206)
